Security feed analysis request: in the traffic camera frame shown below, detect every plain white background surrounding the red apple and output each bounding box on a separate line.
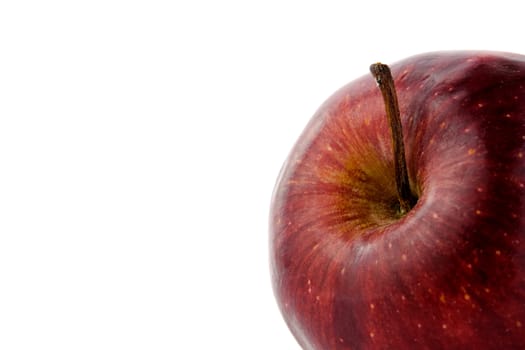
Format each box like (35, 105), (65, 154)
(0, 0), (525, 350)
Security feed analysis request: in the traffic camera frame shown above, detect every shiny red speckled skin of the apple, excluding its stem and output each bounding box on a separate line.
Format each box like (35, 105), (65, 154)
(269, 51), (525, 350)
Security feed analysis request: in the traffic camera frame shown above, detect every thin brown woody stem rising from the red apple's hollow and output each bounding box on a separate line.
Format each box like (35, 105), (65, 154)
(370, 63), (417, 214)
